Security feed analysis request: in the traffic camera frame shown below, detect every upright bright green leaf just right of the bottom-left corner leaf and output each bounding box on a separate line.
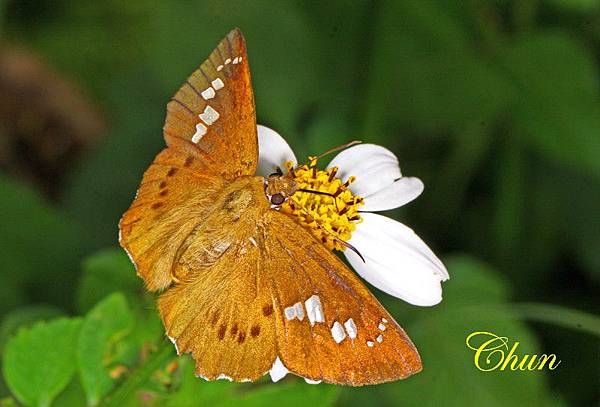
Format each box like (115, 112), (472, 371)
(77, 293), (133, 406)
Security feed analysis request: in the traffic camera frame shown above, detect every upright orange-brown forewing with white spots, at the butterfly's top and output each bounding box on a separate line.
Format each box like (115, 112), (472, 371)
(164, 29), (258, 179)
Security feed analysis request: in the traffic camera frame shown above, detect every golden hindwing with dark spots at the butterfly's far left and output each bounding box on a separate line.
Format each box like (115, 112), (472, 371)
(119, 141), (224, 291)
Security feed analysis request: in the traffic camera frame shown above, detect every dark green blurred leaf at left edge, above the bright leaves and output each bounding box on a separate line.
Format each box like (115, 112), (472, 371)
(0, 176), (87, 312)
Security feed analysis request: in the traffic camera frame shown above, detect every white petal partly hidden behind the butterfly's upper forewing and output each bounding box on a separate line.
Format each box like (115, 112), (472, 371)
(256, 124), (298, 177)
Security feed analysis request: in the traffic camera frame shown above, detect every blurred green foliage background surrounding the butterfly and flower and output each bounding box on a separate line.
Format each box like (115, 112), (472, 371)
(0, 0), (600, 406)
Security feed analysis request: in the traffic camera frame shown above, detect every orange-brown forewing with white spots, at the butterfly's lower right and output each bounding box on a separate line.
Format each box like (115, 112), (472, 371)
(265, 211), (421, 386)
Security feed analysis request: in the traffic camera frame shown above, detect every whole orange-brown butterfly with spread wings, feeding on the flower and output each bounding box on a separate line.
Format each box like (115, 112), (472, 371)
(119, 29), (421, 386)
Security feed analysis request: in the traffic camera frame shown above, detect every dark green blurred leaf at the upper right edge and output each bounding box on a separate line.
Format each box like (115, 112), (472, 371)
(504, 31), (600, 177)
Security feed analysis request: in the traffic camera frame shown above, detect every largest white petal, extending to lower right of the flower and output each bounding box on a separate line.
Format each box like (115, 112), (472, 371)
(344, 213), (448, 306)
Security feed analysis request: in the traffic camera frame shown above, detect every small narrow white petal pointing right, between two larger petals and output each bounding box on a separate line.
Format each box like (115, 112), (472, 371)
(360, 177), (424, 212)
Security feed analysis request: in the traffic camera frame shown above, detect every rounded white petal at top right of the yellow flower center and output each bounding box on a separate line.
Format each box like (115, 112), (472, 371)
(327, 144), (402, 197)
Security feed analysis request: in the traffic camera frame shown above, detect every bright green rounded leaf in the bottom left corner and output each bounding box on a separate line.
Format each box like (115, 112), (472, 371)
(3, 318), (81, 407)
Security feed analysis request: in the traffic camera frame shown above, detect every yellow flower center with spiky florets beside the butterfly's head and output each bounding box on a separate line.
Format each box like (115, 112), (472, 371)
(280, 157), (364, 250)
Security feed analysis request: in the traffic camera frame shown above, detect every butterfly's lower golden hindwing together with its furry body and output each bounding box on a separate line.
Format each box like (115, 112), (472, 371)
(158, 177), (276, 381)
